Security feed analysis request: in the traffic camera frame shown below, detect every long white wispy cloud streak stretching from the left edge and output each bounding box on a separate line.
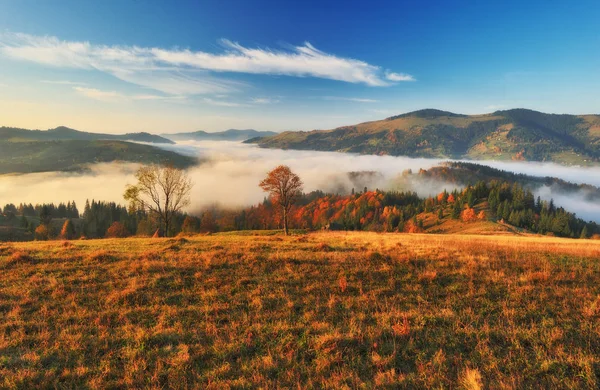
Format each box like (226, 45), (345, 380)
(0, 33), (414, 95)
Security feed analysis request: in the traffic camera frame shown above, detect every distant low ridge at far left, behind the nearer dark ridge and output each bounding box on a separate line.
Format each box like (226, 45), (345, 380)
(0, 126), (175, 144)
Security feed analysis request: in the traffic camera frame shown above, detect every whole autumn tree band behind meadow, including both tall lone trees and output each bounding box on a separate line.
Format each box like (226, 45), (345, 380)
(3, 166), (600, 239)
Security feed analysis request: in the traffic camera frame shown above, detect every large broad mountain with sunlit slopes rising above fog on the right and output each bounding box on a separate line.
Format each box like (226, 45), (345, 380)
(246, 109), (600, 164)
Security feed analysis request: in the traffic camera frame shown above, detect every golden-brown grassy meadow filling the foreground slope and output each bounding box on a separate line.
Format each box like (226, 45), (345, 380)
(0, 232), (600, 389)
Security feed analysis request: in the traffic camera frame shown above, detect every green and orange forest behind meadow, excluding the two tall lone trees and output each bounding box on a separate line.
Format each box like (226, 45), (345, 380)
(0, 180), (600, 240)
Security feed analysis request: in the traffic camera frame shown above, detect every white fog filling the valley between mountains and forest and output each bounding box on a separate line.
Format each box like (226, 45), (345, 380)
(0, 141), (600, 222)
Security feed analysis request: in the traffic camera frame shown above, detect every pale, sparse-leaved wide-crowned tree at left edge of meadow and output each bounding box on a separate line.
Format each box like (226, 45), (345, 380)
(123, 165), (194, 236)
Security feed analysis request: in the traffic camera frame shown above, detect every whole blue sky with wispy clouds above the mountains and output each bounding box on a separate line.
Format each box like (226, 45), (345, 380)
(0, 0), (600, 133)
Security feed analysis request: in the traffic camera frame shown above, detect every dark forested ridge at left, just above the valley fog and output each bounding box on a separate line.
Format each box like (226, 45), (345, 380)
(0, 140), (197, 174)
